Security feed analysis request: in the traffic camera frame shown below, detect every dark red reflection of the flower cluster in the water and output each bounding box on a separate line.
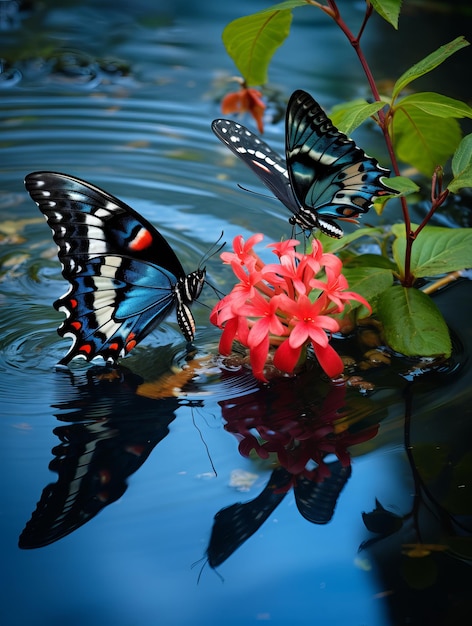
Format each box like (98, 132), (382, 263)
(220, 368), (378, 481)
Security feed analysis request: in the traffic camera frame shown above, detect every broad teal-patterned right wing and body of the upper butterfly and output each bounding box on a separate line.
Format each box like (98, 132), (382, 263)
(285, 90), (397, 237)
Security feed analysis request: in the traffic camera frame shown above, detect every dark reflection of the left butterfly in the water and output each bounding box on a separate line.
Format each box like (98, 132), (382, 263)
(19, 367), (199, 548)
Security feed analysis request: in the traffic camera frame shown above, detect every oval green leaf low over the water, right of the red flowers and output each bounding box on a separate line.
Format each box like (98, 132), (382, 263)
(377, 285), (451, 357)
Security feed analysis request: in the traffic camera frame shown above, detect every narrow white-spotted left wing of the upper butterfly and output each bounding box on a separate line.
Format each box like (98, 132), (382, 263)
(211, 119), (299, 214)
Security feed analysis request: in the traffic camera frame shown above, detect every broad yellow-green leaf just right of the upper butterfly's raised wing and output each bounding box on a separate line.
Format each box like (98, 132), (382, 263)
(392, 103), (461, 176)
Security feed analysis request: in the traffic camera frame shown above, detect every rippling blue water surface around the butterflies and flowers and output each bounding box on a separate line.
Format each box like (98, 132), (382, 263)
(0, 0), (472, 626)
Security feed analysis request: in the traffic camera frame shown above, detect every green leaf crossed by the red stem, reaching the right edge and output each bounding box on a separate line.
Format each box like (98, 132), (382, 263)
(392, 226), (472, 278)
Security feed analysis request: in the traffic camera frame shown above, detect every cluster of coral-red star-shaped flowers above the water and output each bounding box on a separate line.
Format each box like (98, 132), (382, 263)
(210, 234), (370, 381)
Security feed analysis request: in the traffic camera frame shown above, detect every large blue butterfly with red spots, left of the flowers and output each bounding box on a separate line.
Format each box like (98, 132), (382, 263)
(25, 172), (206, 365)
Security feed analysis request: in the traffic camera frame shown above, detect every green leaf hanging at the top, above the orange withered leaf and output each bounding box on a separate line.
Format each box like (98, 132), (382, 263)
(223, 0), (298, 86)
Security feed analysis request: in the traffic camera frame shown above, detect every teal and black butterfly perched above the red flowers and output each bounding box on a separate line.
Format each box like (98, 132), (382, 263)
(212, 90), (397, 238)
